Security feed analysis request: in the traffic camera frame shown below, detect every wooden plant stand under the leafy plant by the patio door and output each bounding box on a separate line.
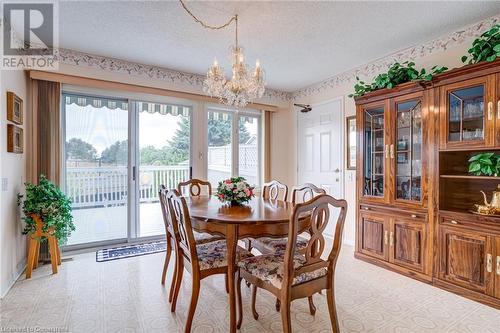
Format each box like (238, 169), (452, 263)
(26, 215), (61, 279)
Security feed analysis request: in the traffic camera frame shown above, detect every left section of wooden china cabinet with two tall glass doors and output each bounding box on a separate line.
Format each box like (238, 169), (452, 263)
(356, 83), (431, 281)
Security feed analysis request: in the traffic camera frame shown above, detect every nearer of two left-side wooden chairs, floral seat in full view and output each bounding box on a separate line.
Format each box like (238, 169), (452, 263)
(167, 190), (252, 332)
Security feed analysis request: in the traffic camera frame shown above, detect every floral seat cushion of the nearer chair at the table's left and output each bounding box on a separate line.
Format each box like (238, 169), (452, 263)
(196, 240), (253, 270)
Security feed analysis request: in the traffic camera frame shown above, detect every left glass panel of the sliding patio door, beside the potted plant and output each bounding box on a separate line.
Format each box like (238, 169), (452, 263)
(61, 93), (130, 245)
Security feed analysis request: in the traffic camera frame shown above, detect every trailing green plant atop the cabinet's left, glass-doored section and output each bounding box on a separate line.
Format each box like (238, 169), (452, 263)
(349, 61), (448, 97)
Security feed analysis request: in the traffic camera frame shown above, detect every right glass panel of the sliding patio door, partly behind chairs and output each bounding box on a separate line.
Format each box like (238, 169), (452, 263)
(134, 101), (192, 237)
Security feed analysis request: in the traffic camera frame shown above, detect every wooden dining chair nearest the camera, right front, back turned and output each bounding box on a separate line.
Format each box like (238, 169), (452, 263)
(236, 194), (347, 333)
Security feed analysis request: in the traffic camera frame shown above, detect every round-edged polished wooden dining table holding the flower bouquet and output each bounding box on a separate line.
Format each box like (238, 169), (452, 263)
(186, 196), (310, 333)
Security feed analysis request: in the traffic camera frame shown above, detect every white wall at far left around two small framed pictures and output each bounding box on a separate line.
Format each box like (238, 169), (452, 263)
(0, 70), (28, 297)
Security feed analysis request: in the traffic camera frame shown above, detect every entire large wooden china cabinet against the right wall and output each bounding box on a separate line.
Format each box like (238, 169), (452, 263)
(355, 61), (500, 308)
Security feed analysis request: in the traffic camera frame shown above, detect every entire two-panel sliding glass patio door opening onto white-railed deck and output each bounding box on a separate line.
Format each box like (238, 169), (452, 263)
(62, 92), (192, 247)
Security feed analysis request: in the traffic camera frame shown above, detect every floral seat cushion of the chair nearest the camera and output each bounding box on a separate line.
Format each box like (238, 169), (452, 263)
(238, 254), (328, 289)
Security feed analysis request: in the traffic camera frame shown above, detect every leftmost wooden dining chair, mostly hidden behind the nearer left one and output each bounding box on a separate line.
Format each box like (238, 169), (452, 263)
(158, 185), (221, 302)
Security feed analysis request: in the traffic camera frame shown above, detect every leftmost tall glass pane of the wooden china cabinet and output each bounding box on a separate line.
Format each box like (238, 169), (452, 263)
(363, 107), (385, 197)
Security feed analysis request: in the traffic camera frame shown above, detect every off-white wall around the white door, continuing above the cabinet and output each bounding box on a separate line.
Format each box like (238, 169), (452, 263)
(286, 39), (473, 244)
